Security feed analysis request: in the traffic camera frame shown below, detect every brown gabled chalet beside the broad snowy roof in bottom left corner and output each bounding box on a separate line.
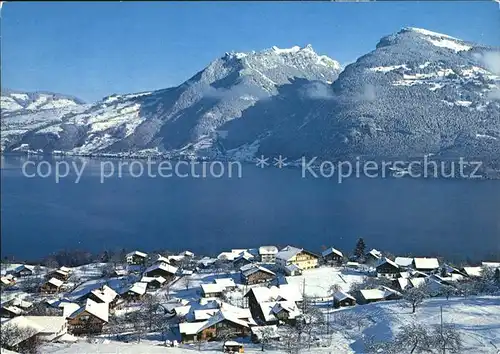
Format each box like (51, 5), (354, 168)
(68, 299), (109, 335)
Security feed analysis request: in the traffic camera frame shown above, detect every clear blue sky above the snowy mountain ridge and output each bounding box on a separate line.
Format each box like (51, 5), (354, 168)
(2, 1), (500, 101)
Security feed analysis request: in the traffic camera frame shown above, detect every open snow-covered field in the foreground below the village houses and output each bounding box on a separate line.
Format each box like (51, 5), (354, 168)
(43, 296), (500, 354)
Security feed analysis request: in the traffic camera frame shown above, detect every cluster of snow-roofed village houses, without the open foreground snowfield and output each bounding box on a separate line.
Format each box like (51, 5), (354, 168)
(0, 239), (500, 353)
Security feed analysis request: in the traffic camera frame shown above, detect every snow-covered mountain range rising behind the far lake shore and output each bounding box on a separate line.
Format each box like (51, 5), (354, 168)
(2, 28), (500, 163)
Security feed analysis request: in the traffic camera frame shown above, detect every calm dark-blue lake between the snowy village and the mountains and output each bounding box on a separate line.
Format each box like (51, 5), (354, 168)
(1, 156), (500, 260)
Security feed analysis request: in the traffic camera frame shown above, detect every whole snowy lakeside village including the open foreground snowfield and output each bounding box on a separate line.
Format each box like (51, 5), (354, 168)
(0, 239), (500, 353)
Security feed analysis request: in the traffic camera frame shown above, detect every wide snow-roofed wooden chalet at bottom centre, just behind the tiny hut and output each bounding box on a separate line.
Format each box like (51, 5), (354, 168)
(179, 311), (250, 342)
